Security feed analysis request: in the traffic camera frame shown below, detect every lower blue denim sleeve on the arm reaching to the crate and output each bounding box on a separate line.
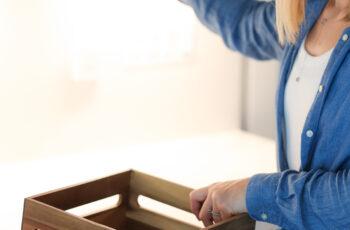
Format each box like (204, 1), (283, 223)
(246, 170), (350, 229)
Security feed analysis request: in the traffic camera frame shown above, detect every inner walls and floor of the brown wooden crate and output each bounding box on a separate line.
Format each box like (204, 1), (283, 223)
(25, 171), (198, 230)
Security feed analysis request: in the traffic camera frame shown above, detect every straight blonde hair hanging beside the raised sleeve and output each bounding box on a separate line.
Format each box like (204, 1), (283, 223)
(276, 0), (306, 44)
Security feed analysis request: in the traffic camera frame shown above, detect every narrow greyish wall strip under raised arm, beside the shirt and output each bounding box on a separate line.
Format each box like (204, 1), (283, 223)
(242, 59), (279, 139)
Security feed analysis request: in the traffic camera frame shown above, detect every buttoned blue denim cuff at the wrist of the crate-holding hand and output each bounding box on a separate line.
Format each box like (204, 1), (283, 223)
(246, 173), (281, 225)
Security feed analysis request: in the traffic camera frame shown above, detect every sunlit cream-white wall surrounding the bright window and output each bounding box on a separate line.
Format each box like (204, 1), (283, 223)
(0, 0), (241, 162)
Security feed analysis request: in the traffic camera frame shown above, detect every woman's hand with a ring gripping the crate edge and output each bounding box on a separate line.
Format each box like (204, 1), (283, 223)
(190, 178), (249, 227)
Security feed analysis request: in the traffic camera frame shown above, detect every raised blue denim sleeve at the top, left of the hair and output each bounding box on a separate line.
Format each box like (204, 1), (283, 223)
(181, 0), (283, 60)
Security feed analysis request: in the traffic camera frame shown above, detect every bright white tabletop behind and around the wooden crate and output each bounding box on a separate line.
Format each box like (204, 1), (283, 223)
(0, 131), (276, 229)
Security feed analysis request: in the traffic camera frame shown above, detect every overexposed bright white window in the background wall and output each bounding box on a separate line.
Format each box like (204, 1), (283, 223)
(53, 0), (195, 79)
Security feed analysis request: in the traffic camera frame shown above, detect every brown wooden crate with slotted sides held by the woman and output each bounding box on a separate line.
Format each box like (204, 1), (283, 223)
(22, 170), (255, 230)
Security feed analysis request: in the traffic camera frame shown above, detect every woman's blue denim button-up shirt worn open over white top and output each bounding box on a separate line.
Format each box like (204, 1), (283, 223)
(183, 0), (350, 230)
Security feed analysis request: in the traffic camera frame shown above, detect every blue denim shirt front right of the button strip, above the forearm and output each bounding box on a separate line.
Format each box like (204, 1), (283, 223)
(313, 58), (350, 170)
